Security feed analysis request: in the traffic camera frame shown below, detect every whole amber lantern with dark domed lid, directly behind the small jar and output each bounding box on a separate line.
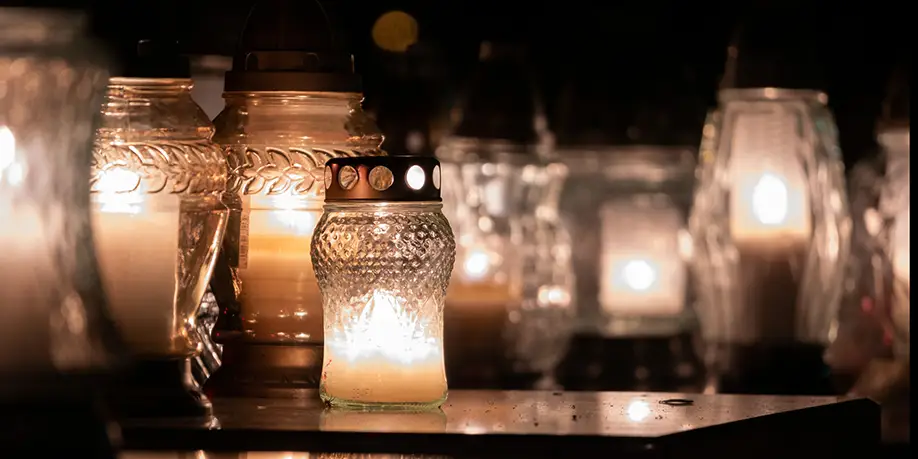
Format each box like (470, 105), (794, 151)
(206, 0), (383, 397)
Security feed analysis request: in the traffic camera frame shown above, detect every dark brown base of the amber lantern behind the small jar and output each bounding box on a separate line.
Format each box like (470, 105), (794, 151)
(204, 342), (324, 398)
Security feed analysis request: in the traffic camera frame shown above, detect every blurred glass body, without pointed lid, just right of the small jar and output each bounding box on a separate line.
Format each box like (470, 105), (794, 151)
(437, 136), (574, 387)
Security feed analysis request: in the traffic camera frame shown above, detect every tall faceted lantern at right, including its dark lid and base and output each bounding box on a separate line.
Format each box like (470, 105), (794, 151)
(689, 20), (852, 395)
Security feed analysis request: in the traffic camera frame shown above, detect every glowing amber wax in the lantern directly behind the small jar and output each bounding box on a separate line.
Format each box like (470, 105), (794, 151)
(238, 201), (322, 342)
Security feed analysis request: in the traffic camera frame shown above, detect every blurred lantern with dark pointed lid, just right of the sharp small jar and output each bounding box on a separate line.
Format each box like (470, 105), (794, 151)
(437, 42), (573, 388)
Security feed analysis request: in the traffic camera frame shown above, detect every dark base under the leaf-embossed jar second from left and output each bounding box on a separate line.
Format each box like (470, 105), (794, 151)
(113, 358), (214, 426)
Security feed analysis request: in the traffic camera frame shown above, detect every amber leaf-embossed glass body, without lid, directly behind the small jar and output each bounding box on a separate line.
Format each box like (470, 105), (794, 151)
(214, 92), (383, 387)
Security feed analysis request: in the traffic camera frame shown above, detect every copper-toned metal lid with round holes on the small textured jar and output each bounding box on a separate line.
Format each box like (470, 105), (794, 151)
(325, 156), (440, 202)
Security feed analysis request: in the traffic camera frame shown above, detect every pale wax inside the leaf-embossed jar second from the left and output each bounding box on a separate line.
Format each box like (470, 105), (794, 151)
(92, 182), (180, 357)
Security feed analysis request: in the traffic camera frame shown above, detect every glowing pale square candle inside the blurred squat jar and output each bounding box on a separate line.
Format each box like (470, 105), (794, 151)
(599, 200), (686, 316)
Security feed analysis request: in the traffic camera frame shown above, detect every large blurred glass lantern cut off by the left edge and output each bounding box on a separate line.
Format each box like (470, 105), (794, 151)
(0, 8), (121, 457)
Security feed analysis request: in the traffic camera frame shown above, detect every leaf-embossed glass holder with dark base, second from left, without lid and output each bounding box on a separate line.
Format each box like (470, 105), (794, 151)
(90, 50), (227, 418)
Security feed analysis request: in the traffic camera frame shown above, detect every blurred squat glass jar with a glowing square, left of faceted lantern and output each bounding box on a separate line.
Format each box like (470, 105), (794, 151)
(559, 146), (695, 336)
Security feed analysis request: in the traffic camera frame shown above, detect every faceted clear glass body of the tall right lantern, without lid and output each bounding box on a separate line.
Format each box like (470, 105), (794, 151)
(689, 88), (851, 388)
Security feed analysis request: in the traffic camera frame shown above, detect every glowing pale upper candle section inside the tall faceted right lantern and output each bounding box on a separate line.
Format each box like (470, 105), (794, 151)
(725, 110), (811, 245)
